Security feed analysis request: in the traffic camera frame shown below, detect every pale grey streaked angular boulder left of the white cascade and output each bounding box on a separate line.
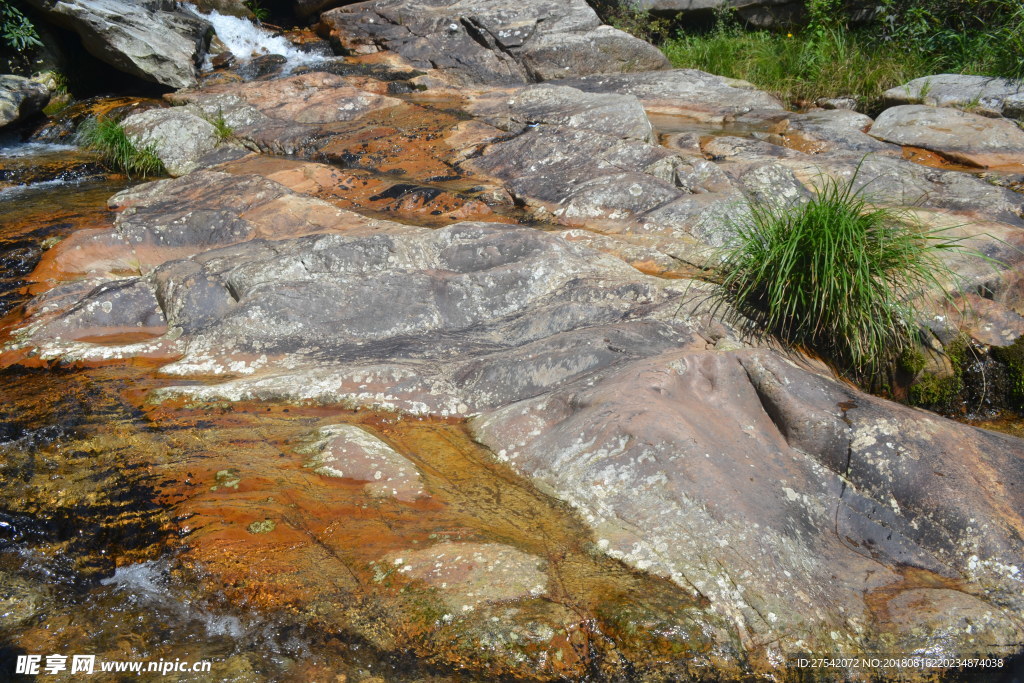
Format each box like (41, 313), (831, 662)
(28, 0), (210, 88)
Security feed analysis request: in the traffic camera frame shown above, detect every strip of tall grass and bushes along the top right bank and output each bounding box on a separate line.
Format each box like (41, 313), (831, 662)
(662, 0), (1024, 113)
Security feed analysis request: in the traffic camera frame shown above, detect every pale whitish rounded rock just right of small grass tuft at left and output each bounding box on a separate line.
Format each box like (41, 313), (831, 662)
(122, 108), (220, 176)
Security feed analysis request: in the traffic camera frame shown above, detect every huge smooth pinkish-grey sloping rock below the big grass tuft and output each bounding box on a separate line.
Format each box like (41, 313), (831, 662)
(473, 350), (1024, 653)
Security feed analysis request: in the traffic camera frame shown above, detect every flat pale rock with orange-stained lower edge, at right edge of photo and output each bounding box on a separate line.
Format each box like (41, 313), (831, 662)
(870, 104), (1024, 168)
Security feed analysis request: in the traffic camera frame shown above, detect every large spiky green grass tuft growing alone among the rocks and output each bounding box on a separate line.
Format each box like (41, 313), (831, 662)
(719, 171), (959, 382)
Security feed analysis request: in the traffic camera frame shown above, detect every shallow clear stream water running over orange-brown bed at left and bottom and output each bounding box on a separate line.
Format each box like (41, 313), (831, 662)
(0, 145), (709, 682)
